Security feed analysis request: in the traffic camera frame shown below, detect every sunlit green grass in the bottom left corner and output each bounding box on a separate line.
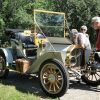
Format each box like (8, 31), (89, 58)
(0, 83), (40, 100)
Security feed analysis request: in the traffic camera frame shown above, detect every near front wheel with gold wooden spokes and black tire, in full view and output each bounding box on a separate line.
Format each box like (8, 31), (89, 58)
(39, 59), (69, 98)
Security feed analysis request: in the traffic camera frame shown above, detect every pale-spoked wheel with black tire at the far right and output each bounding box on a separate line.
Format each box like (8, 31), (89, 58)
(81, 66), (100, 86)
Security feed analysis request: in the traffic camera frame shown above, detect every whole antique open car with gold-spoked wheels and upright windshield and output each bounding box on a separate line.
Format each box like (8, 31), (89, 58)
(0, 10), (100, 97)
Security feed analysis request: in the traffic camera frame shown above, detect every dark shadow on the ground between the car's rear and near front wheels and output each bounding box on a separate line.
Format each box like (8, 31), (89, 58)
(0, 71), (48, 98)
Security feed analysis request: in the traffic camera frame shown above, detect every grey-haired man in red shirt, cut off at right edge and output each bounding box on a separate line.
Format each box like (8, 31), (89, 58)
(92, 17), (100, 51)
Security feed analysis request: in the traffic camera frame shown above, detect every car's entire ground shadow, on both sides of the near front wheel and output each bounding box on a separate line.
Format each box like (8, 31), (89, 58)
(0, 71), (100, 99)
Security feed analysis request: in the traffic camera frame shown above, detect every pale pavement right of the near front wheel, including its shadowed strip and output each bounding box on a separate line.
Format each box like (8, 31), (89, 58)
(60, 80), (100, 100)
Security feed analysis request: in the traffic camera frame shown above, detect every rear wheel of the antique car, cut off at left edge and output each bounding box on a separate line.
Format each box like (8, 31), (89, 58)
(0, 52), (9, 78)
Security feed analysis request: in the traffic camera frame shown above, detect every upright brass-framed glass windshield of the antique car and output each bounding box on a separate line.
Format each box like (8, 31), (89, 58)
(34, 10), (65, 37)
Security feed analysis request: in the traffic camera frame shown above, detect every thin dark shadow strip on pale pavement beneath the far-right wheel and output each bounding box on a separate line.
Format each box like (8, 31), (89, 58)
(70, 80), (100, 92)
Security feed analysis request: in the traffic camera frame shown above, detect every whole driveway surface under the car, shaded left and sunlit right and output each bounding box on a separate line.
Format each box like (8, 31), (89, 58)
(2, 72), (100, 100)
